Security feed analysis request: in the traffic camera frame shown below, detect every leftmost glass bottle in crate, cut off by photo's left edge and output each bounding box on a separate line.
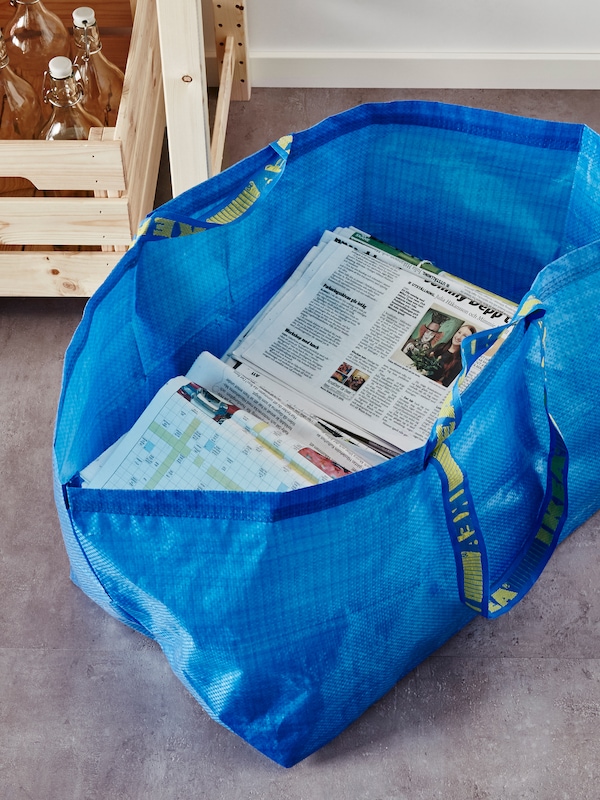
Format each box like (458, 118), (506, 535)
(0, 33), (43, 139)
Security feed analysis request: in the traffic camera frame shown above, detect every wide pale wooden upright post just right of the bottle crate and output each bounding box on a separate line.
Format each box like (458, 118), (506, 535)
(156, 0), (210, 195)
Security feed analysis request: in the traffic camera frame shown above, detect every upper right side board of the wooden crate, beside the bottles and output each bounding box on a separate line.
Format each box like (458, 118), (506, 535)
(115, 0), (165, 234)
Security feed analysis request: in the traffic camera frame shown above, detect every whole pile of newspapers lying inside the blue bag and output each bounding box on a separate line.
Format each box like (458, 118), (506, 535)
(81, 222), (516, 491)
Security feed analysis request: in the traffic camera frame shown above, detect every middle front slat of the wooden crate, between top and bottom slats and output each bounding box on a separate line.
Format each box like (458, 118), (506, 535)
(0, 197), (131, 245)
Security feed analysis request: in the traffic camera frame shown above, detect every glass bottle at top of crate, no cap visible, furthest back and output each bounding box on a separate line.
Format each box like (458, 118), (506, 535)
(4, 0), (70, 97)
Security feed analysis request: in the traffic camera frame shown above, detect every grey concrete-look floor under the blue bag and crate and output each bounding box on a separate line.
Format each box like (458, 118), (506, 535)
(0, 89), (600, 800)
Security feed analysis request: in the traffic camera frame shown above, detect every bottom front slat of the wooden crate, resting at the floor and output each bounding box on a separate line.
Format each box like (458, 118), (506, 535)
(0, 251), (121, 297)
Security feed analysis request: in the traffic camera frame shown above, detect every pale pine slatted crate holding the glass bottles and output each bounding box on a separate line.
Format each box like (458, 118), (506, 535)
(0, 0), (165, 297)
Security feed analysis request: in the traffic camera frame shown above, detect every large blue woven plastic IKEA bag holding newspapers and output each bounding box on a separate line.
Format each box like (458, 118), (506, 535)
(55, 102), (600, 766)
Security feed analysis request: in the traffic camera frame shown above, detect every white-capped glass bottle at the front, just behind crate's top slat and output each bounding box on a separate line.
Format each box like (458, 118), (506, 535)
(38, 56), (102, 141)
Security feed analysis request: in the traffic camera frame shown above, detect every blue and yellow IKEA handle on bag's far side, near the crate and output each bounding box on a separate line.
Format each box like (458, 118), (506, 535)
(134, 135), (293, 243)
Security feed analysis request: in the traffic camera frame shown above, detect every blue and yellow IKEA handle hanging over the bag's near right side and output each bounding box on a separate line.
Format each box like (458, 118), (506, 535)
(425, 294), (569, 618)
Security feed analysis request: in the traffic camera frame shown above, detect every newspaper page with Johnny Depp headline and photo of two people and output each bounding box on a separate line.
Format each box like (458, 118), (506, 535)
(228, 232), (513, 451)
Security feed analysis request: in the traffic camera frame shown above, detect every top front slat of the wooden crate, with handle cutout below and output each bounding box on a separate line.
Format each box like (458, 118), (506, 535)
(0, 140), (125, 191)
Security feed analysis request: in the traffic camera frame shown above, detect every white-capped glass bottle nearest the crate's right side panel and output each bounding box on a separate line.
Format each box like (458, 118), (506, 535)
(73, 6), (124, 127)
